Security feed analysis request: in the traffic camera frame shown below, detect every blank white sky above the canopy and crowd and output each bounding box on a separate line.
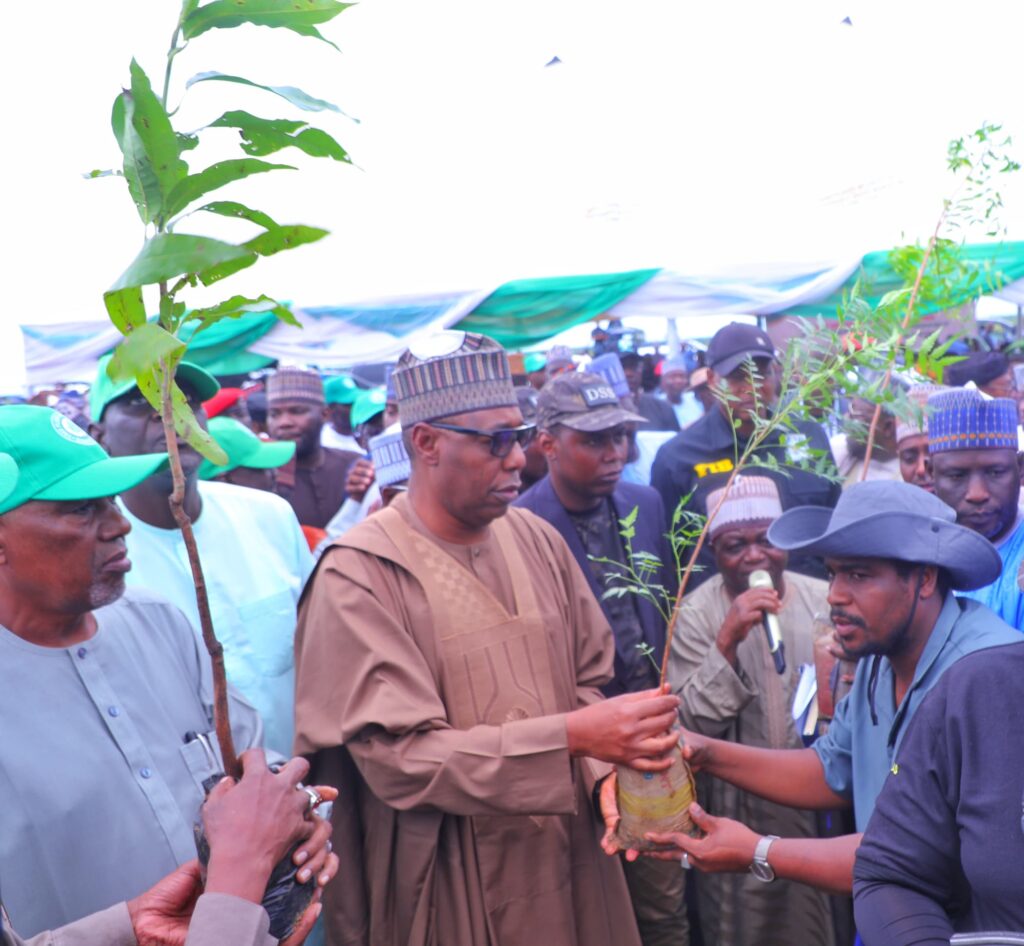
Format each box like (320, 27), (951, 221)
(0, 0), (1024, 387)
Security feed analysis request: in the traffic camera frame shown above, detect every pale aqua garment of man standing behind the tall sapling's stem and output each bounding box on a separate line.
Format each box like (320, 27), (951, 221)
(122, 481), (313, 758)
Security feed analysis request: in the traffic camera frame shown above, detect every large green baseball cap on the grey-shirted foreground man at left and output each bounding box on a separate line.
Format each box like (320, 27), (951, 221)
(0, 404), (167, 514)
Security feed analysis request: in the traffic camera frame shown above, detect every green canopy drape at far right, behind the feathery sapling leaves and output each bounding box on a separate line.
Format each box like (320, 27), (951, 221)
(783, 243), (1024, 318)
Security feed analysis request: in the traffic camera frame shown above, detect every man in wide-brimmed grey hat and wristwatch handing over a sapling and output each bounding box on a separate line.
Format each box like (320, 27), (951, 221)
(622, 480), (1021, 894)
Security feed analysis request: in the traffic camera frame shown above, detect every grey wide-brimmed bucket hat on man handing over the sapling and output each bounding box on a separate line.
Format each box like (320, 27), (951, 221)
(768, 480), (1002, 591)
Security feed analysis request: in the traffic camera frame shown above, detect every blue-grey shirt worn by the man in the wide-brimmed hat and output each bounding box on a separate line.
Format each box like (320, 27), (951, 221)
(812, 595), (1021, 831)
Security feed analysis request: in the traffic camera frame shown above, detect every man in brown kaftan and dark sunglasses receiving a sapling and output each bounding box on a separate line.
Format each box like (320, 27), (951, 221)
(296, 333), (678, 946)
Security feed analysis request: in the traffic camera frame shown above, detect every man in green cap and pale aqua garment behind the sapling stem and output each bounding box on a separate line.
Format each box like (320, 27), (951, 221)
(92, 356), (312, 755)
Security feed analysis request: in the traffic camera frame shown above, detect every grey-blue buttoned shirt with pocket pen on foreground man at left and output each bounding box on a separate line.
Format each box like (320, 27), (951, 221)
(0, 590), (263, 936)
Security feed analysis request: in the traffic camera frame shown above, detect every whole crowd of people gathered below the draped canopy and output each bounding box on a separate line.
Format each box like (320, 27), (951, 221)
(0, 323), (1024, 946)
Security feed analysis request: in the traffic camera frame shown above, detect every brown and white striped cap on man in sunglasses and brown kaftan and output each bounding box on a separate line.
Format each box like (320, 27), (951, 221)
(391, 331), (519, 427)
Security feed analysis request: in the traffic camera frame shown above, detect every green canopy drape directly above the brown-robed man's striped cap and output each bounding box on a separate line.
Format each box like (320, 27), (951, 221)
(455, 269), (660, 349)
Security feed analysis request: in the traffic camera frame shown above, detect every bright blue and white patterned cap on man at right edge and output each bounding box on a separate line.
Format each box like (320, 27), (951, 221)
(928, 388), (1017, 454)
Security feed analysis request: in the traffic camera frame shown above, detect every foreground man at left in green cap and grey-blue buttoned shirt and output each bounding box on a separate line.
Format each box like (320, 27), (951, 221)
(0, 404), (335, 943)
